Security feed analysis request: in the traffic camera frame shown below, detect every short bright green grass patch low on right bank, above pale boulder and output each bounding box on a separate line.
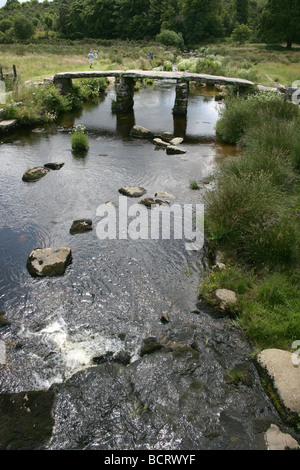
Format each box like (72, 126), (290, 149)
(200, 261), (300, 350)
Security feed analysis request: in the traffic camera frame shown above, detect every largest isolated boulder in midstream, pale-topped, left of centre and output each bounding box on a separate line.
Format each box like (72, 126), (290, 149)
(26, 248), (72, 277)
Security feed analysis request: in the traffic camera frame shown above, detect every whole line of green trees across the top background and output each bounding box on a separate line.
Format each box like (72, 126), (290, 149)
(0, 0), (300, 48)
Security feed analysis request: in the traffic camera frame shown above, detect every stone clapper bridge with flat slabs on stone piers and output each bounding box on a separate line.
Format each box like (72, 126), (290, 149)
(53, 70), (254, 116)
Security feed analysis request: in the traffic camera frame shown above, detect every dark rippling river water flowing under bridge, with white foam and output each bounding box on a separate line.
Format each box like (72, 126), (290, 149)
(0, 82), (296, 450)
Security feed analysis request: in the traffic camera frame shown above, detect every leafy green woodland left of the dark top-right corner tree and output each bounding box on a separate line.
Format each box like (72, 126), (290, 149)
(0, 0), (272, 48)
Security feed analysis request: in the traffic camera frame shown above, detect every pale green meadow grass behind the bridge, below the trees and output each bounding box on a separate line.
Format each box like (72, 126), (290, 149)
(0, 40), (300, 86)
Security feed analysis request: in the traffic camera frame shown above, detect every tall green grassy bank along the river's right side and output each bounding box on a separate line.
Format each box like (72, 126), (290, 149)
(200, 93), (300, 349)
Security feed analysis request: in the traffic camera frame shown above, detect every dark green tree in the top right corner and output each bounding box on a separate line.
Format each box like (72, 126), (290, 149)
(259, 0), (300, 49)
